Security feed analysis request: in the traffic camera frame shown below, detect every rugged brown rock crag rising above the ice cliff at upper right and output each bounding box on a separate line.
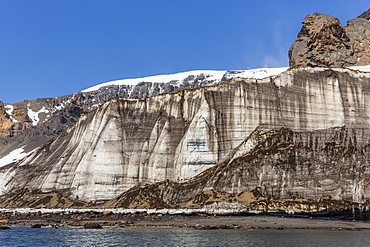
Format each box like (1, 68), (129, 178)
(289, 10), (370, 67)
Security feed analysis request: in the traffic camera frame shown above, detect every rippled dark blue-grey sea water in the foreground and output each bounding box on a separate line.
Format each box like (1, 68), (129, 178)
(0, 226), (370, 246)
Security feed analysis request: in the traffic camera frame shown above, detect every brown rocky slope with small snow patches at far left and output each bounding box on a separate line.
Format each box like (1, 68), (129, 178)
(0, 94), (86, 158)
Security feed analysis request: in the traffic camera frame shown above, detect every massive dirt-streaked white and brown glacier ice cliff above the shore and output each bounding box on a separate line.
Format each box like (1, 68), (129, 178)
(0, 68), (370, 204)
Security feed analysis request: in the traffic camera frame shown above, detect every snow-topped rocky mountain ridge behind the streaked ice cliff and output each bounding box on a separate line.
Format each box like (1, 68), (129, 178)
(0, 68), (287, 166)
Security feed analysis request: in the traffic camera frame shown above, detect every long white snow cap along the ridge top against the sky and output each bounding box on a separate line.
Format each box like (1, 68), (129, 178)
(82, 67), (288, 92)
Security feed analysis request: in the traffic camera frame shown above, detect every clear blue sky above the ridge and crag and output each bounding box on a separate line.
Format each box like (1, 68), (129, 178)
(0, 0), (370, 103)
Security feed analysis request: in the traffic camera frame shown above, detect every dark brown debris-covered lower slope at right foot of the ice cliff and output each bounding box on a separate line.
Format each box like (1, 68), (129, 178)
(105, 127), (370, 213)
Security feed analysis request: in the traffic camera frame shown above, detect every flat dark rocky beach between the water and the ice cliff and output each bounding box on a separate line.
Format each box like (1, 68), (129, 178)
(0, 210), (370, 230)
